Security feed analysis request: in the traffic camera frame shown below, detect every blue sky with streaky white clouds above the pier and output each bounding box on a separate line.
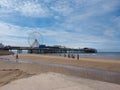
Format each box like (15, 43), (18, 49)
(0, 0), (120, 52)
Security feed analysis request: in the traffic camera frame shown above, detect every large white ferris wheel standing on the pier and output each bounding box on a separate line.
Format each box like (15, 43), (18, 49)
(28, 31), (43, 48)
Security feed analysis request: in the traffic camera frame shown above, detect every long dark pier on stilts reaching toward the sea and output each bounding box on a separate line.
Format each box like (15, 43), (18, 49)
(9, 46), (97, 54)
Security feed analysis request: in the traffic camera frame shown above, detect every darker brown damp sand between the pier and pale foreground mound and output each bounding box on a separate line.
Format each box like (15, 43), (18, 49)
(0, 54), (120, 90)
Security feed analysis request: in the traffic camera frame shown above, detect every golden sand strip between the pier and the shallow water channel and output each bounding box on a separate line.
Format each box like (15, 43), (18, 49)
(8, 54), (120, 72)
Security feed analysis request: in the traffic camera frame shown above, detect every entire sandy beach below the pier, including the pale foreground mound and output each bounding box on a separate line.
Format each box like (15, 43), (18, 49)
(0, 54), (120, 90)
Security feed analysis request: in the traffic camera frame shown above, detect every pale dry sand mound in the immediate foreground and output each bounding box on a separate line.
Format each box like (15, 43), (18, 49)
(0, 73), (120, 90)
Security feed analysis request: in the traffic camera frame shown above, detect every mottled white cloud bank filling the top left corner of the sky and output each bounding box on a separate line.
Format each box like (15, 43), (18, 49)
(0, 0), (49, 17)
